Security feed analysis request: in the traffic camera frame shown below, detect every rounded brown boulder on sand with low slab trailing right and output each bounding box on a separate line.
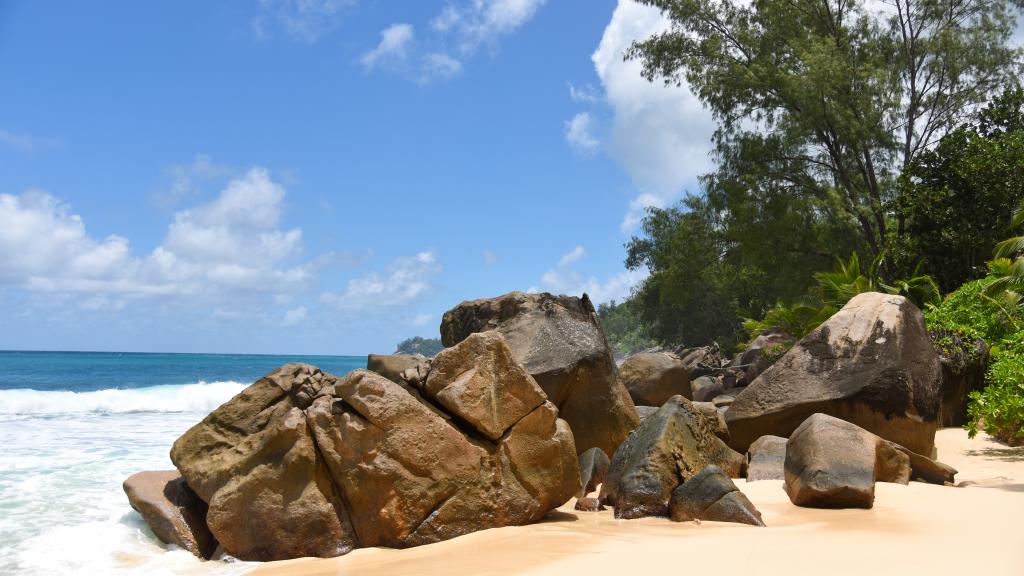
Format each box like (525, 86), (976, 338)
(784, 414), (956, 508)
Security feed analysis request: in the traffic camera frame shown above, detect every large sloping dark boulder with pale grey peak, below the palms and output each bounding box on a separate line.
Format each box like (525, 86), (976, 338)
(725, 292), (941, 455)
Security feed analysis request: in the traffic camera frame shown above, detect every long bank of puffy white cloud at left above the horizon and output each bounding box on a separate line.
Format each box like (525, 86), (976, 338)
(0, 168), (308, 295)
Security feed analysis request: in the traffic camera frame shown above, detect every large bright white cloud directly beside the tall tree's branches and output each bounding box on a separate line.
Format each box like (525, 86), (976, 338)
(592, 0), (715, 232)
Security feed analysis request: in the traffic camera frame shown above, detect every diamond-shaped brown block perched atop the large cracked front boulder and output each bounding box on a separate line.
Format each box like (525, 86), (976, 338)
(424, 332), (546, 440)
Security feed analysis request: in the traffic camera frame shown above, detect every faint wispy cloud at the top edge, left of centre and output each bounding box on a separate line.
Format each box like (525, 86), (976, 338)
(251, 0), (356, 44)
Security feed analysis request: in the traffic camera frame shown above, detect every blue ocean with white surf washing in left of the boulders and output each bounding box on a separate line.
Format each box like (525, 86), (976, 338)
(0, 352), (366, 576)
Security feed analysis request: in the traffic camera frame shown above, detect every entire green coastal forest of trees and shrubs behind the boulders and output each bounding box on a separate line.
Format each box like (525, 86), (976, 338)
(598, 0), (1024, 444)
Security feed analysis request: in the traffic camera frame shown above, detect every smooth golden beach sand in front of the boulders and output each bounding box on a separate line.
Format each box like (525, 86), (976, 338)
(251, 428), (1024, 576)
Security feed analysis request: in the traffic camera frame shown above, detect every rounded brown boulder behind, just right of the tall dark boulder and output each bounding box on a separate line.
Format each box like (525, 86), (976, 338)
(618, 352), (693, 406)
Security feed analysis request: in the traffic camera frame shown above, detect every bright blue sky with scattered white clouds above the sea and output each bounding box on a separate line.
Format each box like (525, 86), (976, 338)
(0, 0), (1019, 355)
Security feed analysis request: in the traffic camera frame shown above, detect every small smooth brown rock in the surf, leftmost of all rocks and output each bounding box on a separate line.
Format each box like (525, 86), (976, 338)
(124, 470), (217, 559)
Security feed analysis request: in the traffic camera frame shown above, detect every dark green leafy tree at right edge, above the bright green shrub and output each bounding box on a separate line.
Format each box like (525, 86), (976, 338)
(888, 88), (1024, 291)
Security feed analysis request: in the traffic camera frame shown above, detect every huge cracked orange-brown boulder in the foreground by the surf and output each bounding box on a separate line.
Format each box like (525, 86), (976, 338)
(171, 333), (580, 561)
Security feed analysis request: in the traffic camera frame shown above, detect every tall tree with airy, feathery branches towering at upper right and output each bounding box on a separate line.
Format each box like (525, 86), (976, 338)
(627, 0), (1022, 257)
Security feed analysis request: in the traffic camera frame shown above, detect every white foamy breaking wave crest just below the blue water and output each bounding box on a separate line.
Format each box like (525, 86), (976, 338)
(0, 381), (246, 417)
